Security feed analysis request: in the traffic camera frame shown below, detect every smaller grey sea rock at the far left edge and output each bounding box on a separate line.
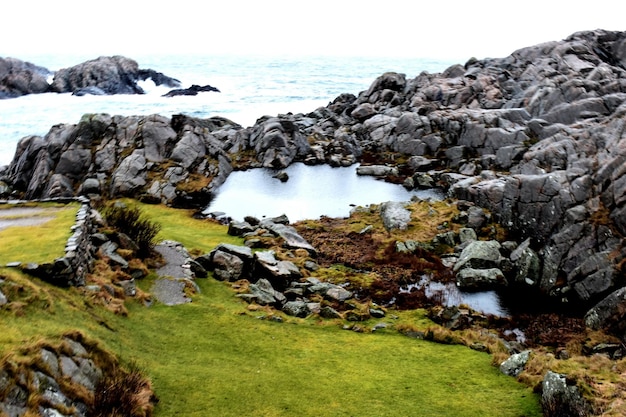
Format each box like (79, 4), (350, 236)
(0, 57), (52, 99)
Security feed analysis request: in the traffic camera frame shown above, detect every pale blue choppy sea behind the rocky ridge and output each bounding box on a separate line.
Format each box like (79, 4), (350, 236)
(0, 52), (456, 166)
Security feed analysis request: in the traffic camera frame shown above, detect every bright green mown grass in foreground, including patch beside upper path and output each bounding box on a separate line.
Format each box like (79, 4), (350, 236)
(0, 201), (540, 416)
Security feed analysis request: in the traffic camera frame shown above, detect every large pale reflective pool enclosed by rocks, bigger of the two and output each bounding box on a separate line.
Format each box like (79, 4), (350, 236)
(208, 163), (442, 221)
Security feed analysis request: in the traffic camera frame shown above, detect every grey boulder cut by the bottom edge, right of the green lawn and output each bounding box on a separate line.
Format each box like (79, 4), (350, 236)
(541, 371), (590, 417)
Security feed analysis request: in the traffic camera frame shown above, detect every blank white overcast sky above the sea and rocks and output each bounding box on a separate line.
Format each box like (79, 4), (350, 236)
(0, 0), (626, 59)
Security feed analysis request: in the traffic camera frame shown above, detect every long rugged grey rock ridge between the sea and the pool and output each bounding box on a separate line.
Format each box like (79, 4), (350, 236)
(0, 30), (626, 334)
